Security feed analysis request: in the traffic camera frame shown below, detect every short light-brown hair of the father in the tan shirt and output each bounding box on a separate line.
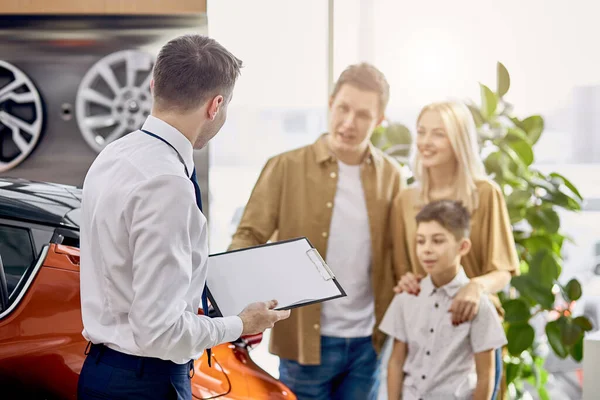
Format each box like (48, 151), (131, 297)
(331, 63), (390, 113)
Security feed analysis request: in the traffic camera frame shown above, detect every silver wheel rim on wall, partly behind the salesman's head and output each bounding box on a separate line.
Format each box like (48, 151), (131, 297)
(75, 50), (154, 152)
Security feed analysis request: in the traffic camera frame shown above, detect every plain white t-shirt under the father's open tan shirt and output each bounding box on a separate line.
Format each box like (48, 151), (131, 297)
(321, 161), (375, 338)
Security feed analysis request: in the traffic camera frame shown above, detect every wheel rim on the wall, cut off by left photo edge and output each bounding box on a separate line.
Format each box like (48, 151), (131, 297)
(0, 60), (44, 172)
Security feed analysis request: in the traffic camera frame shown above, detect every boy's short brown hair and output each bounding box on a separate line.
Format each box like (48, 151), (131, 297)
(416, 200), (471, 240)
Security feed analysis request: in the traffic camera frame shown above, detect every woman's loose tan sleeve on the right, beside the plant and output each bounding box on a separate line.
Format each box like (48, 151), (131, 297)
(479, 182), (519, 275)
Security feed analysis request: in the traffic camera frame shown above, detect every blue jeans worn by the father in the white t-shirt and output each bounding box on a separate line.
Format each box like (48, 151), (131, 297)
(279, 336), (379, 400)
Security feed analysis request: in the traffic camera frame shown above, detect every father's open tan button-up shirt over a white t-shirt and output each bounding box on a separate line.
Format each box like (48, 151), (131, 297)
(230, 135), (403, 365)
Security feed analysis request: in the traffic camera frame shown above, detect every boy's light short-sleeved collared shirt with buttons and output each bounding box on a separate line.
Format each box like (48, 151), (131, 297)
(379, 268), (506, 400)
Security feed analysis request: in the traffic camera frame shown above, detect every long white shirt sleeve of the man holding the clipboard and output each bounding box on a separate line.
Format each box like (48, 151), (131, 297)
(124, 175), (243, 359)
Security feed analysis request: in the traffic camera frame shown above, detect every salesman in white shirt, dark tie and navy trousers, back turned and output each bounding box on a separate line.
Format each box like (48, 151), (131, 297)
(78, 35), (289, 400)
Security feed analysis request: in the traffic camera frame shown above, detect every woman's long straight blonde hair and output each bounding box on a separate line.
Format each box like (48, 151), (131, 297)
(413, 101), (487, 212)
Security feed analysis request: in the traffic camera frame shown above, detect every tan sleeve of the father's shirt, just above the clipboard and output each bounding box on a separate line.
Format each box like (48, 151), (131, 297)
(229, 157), (283, 250)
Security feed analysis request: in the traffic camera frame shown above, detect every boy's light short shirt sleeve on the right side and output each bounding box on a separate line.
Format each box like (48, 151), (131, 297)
(470, 296), (507, 353)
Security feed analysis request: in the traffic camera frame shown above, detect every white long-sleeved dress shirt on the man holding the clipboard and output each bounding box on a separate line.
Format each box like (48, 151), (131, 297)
(80, 116), (243, 364)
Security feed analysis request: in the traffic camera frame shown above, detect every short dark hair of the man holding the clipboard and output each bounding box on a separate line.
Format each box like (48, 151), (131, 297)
(153, 35), (242, 112)
